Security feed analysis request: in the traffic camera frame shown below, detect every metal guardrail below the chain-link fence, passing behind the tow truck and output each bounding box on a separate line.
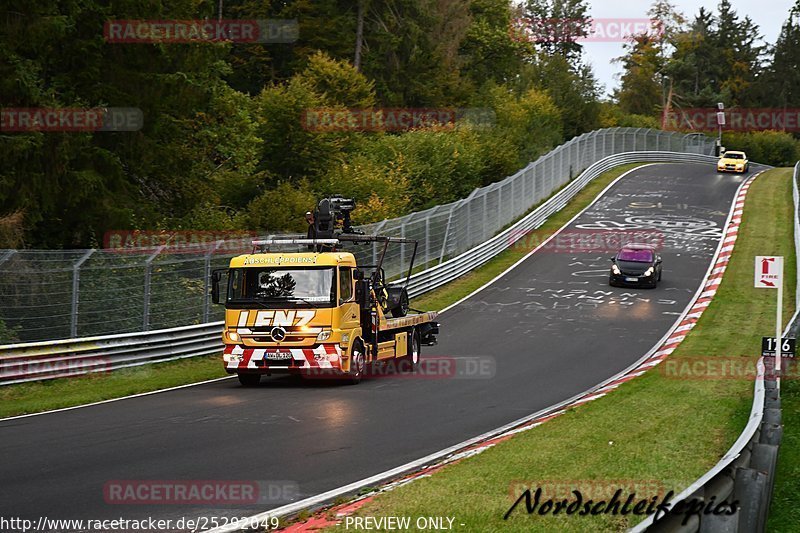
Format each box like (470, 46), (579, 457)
(0, 152), (715, 385)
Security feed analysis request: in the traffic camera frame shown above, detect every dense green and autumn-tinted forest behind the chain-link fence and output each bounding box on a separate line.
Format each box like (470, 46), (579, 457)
(0, 0), (800, 248)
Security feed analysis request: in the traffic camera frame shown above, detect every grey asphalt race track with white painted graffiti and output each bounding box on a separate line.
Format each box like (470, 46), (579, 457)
(0, 164), (757, 519)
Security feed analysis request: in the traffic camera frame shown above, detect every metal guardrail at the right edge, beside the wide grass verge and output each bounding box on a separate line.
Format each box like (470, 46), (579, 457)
(630, 162), (800, 533)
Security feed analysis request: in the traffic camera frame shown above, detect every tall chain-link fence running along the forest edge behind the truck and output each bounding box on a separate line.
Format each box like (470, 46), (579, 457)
(0, 128), (714, 343)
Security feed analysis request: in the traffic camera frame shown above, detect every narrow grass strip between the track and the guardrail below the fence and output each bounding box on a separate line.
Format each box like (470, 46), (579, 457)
(0, 164), (639, 417)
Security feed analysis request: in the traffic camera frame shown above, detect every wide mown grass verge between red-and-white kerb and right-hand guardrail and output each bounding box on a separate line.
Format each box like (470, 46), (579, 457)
(322, 169), (800, 531)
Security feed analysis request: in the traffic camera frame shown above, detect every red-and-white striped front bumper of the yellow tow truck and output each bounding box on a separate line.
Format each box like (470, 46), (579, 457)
(222, 343), (342, 374)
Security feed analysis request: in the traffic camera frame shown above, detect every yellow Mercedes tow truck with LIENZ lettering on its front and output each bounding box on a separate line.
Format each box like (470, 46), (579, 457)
(211, 197), (439, 387)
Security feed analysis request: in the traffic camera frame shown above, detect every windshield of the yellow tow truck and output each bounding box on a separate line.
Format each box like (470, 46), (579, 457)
(227, 267), (336, 308)
